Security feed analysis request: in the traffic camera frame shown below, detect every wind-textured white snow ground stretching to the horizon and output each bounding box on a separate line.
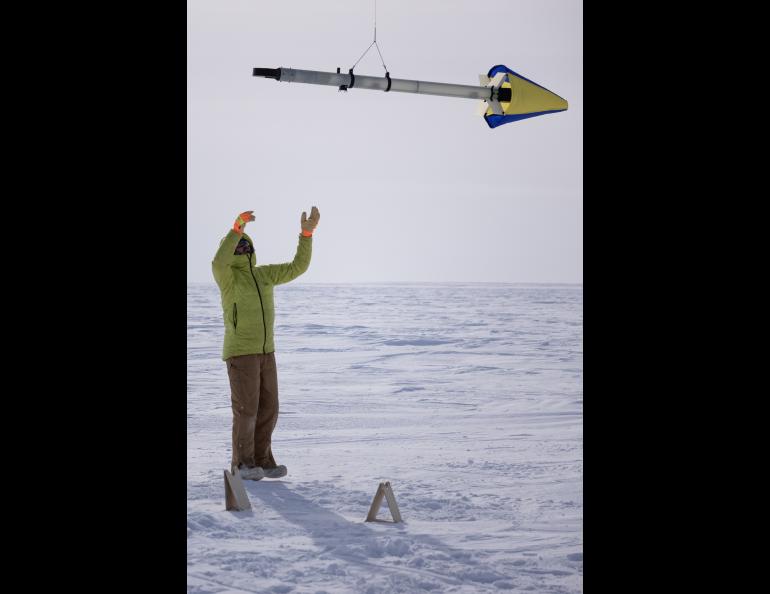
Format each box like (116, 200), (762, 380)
(187, 283), (583, 594)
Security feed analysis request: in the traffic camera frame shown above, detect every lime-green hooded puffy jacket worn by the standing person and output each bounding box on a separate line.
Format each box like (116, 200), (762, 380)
(211, 230), (313, 360)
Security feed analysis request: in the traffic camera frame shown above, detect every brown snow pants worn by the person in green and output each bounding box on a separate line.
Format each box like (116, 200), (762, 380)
(226, 353), (278, 472)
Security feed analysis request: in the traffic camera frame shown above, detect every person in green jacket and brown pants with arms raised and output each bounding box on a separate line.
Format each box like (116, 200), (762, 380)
(211, 206), (321, 480)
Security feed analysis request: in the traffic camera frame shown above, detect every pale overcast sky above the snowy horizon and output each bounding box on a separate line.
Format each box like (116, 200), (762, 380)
(187, 0), (583, 283)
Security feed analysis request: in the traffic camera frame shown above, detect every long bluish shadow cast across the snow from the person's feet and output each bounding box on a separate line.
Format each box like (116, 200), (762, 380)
(247, 481), (510, 585)
